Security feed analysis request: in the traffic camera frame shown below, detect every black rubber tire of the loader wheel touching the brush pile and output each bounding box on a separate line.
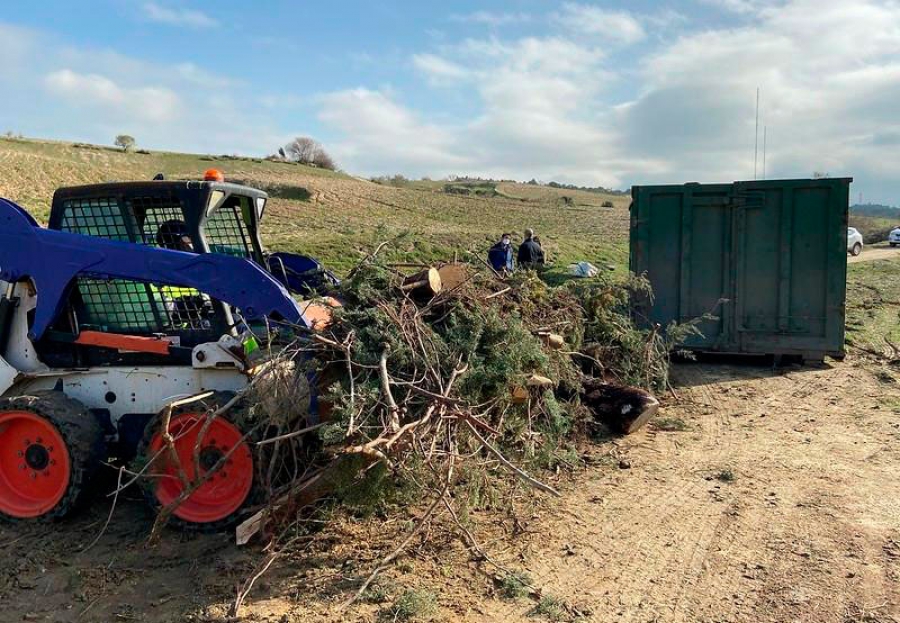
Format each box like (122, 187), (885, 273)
(135, 392), (261, 533)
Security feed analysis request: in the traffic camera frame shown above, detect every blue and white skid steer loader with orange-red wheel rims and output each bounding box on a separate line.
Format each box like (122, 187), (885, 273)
(0, 171), (337, 529)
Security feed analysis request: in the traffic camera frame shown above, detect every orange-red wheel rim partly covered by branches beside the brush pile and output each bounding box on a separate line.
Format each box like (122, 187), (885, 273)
(149, 413), (253, 523)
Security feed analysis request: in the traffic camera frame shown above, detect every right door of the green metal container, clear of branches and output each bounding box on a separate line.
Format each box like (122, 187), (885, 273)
(735, 180), (849, 355)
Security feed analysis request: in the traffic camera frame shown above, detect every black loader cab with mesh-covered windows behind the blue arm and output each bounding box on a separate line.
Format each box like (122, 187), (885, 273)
(38, 180), (268, 366)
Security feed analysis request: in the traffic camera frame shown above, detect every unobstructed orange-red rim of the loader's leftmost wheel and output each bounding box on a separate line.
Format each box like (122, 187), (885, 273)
(0, 411), (72, 519)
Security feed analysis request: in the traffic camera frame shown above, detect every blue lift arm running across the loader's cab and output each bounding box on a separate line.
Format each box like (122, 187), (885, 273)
(0, 199), (310, 340)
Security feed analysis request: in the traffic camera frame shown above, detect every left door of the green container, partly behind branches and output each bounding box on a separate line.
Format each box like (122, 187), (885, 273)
(631, 184), (734, 350)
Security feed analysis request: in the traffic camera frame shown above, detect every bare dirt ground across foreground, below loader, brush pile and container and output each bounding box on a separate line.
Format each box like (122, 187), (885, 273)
(0, 358), (900, 623)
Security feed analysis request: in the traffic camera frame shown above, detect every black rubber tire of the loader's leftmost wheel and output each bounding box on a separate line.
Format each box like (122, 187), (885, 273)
(0, 390), (107, 522)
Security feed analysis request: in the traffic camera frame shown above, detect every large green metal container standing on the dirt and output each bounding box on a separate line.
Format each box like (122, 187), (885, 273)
(631, 178), (852, 360)
